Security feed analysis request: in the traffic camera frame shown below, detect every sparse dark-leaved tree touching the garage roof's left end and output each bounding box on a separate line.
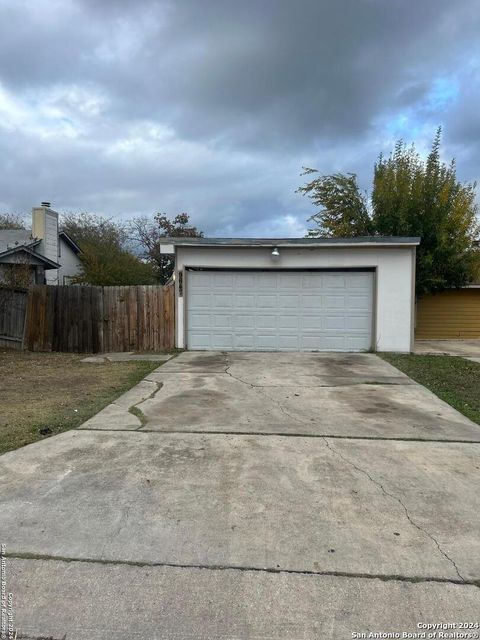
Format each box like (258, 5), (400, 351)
(130, 213), (203, 284)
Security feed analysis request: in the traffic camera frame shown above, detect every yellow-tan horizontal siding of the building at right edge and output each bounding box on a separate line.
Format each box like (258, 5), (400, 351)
(415, 288), (480, 340)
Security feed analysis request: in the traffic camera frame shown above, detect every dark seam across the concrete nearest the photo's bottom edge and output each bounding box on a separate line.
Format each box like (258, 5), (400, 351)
(5, 553), (480, 589)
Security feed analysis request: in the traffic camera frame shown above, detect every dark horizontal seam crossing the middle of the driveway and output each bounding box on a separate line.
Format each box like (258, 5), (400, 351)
(70, 423), (480, 445)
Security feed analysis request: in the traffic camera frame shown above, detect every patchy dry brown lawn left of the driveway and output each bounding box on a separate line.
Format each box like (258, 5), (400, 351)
(0, 351), (159, 454)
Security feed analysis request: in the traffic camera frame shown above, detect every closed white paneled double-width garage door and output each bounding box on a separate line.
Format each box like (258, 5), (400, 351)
(186, 271), (373, 351)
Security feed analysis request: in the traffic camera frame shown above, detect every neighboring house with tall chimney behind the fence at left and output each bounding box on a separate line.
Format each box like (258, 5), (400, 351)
(0, 202), (81, 284)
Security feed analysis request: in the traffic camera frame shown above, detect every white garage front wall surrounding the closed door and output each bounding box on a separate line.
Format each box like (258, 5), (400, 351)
(175, 246), (415, 352)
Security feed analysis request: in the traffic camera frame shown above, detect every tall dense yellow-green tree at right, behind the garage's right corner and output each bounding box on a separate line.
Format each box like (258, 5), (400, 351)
(372, 129), (479, 295)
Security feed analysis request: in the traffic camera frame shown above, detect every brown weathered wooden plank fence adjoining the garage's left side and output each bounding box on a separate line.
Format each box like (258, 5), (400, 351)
(24, 285), (175, 353)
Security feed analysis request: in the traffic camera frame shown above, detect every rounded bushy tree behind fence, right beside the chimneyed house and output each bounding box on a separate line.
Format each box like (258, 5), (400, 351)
(62, 213), (156, 286)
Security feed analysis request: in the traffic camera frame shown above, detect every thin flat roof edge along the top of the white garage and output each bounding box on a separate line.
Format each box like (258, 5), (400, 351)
(160, 236), (420, 254)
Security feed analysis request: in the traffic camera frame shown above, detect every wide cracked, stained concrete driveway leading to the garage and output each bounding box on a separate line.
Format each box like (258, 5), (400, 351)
(0, 352), (480, 640)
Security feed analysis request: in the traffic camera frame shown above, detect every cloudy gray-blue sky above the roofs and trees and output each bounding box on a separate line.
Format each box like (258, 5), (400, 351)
(0, 0), (480, 236)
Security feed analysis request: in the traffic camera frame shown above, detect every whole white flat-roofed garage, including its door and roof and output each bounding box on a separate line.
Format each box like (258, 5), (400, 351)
(161, 237), (420, 352)
